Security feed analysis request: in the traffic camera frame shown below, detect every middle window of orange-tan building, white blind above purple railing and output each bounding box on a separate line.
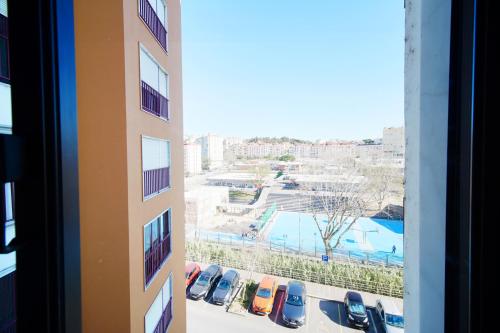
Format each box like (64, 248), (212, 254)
(142, 136), (171, 199)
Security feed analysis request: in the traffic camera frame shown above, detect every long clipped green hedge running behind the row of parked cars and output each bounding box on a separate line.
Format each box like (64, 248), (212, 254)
(185, 243), (403, 298)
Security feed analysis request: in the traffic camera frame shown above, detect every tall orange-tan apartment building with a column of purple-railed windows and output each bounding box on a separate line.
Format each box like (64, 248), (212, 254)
(74, 0), (186, 333)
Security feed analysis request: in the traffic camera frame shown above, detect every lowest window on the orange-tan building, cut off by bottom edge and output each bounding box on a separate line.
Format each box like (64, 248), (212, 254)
(144, 273), (173, 333)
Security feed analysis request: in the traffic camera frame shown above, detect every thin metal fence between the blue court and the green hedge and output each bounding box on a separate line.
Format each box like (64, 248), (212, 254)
(189, 230), (403, 268)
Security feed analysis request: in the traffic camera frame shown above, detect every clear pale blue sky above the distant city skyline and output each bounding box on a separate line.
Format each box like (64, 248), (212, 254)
(182, 0), (404, 140)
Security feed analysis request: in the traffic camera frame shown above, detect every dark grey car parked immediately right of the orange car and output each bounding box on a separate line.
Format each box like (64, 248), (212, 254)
(282, 280), (307, 327)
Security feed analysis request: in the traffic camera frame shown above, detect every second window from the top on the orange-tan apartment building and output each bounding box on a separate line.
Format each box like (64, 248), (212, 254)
(140, 46), (170, 120)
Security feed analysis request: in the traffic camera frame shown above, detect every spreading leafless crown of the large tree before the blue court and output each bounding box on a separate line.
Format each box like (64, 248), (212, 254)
(309, 173), (367, 257)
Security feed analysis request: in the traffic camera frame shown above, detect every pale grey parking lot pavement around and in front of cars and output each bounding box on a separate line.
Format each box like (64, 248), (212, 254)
(186, 264), (392, 333)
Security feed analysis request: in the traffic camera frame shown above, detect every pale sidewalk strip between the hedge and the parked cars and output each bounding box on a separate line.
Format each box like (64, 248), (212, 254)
(193, 263), (403, 313)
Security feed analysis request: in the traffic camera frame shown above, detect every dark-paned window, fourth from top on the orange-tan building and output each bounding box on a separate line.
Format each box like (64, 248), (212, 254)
(144, 209), (172, 286)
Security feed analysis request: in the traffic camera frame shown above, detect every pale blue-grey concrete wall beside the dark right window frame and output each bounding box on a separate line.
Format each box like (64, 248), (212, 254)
(404, 0), (451, 333)
